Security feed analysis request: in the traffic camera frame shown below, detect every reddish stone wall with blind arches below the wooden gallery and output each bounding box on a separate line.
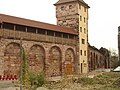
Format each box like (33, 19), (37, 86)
(0, 38), (77, 76)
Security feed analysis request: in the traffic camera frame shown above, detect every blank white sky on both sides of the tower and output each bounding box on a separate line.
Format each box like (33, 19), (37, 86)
(0, 0), (120, 50)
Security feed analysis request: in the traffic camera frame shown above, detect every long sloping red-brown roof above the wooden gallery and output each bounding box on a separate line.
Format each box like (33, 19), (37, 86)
(0, 14), (78, 35)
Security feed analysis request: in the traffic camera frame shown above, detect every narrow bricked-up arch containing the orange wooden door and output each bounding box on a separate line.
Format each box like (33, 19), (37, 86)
(64, 48), (75, 75)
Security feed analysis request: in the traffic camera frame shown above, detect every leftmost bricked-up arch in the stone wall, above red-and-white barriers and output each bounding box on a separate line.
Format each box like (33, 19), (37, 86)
(4, 42), (20, 75)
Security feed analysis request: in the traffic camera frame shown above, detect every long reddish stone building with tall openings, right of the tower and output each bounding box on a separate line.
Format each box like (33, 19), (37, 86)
(88, 45), (110, 71)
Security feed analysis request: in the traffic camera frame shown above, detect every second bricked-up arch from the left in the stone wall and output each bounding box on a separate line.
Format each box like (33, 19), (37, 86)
(28, 44), (45, 73)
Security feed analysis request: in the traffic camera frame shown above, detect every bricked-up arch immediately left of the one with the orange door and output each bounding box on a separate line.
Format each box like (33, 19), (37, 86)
(48, 46), (62, 76)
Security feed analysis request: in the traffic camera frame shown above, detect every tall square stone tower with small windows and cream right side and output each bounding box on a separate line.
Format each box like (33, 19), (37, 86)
(54, 0), (89, 73)
